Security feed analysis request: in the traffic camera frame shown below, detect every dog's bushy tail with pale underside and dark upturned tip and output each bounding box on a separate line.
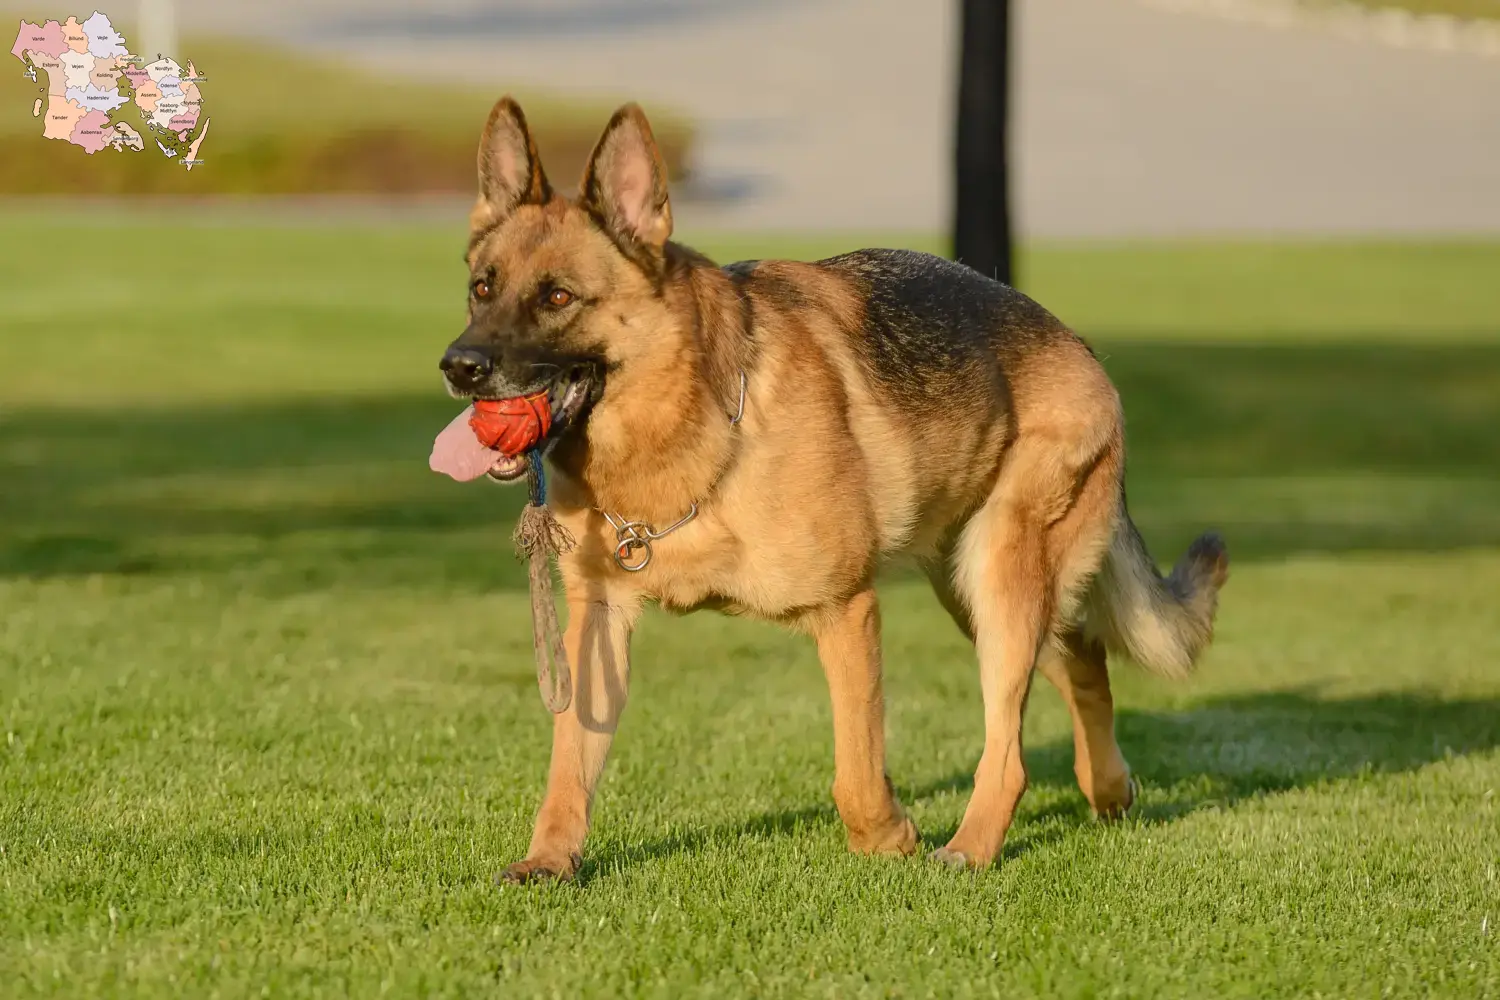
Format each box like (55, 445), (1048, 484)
(1088, 496), (1229, 678)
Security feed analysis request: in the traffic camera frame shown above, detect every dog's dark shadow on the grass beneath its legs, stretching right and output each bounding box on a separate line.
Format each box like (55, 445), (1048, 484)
(581, 688), (1500, 882)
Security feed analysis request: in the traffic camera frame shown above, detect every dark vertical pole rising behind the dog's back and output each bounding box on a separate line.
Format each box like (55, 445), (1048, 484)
(953, 0), (1013, 285)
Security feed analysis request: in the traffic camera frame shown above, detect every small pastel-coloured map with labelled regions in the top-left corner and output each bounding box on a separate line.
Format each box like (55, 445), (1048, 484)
(11, 10), (209, 169)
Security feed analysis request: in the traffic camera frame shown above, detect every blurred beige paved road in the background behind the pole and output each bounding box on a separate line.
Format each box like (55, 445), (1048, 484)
(180, 0), (1500, 237)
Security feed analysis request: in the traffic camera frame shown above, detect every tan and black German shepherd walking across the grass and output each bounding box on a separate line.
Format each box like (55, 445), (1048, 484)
(441, 97), (1229, 882)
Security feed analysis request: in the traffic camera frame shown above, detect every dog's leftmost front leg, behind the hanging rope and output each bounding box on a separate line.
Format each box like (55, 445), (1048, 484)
(503, 594), (639, 883)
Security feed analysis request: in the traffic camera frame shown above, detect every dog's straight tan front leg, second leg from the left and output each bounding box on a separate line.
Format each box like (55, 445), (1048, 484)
(812, 589), (917, 855)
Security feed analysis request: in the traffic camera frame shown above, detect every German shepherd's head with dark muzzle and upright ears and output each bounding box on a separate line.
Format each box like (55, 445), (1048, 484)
(441, 97), (672, 478)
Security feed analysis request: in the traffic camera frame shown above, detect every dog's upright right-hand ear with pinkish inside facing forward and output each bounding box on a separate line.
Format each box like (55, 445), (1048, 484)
(582, 103), (672, 249)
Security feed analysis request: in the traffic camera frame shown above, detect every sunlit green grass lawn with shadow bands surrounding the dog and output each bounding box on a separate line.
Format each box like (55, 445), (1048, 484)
(0, 216), (1500, 999)
